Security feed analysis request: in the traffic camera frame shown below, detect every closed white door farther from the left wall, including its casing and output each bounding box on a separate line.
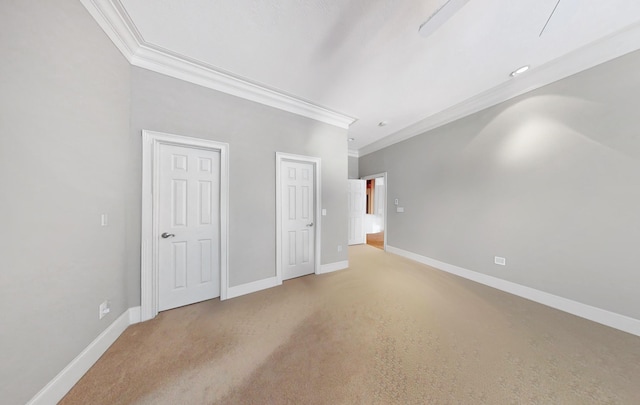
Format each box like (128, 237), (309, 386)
(276, 153), (320, 282)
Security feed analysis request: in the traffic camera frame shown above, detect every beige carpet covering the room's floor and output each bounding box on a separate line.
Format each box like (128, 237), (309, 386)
(62, 245), (640, 404)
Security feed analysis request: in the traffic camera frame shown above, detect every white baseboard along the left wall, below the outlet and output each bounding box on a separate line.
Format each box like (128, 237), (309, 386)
(27, 307), (140, 405)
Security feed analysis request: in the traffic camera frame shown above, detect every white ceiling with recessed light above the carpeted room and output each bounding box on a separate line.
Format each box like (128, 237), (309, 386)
(89, 0), (640, 154)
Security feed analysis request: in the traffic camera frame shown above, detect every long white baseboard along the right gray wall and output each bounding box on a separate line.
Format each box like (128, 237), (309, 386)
(387, 246), (640, 336)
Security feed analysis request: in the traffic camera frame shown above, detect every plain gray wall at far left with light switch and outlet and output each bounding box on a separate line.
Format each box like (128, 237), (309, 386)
(0, 0), (130, 404)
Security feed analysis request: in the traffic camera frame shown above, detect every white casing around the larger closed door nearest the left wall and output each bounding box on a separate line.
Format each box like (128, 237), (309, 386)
(140, 130), (229, 321)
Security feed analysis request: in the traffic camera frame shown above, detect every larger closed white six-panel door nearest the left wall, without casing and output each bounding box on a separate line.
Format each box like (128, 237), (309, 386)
(157, 144), (220, 311)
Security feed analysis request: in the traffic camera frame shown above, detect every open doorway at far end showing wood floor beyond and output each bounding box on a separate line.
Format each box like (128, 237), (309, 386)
(364, 174), (387, 250)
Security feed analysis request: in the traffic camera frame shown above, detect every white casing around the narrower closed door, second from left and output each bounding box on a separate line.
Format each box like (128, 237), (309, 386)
(276, 152), (322, 284)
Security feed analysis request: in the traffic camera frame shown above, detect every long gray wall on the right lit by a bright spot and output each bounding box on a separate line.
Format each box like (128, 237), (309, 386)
(359, 52), (640, 319)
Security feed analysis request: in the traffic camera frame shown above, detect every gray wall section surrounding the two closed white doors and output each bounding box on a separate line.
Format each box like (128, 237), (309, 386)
(128, 68), (347, 288)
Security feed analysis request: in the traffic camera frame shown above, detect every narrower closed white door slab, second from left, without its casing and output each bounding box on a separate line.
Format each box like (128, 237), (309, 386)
(280, 160), (316, 280)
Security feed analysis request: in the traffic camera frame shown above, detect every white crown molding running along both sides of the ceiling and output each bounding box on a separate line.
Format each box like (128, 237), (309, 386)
(80, 0), (640, 157)
